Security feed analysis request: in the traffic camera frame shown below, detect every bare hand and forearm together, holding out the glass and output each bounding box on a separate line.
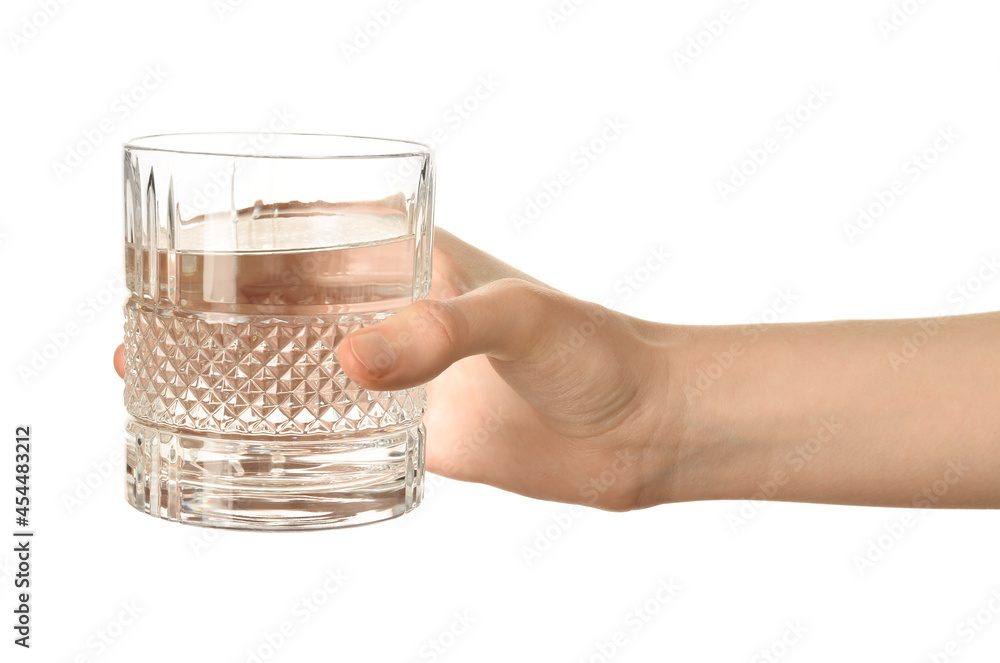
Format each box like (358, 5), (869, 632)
(115, 229), (1000, 511)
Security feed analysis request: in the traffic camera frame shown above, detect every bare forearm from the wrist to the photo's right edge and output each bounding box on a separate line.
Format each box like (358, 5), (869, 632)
(649, 314), (1000, 508)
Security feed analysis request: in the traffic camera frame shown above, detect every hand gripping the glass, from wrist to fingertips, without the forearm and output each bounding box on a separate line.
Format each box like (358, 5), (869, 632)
(115, 229), (671, 511)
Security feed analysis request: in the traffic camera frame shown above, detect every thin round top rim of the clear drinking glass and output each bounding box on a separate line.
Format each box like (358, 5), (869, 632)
(122, 131), (434, 159)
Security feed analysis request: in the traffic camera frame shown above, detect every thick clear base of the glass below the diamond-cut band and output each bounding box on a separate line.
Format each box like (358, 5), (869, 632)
(125, 417), (424, 530)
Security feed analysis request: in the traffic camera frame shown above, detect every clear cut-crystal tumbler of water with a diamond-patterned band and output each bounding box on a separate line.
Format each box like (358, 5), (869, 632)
(124, 133), (434, 530)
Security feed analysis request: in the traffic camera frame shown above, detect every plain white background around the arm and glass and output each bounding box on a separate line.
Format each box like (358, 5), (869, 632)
(0, 0), (1000, 663)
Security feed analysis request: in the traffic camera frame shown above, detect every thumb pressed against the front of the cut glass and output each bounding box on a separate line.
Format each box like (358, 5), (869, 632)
(337, 278), (559, 390)
